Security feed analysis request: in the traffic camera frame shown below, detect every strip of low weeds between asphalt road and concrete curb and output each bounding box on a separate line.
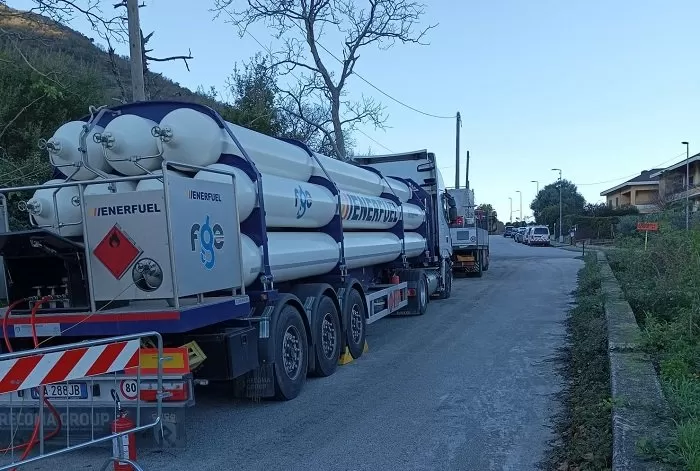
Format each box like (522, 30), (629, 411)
(545, 254), (612, 471)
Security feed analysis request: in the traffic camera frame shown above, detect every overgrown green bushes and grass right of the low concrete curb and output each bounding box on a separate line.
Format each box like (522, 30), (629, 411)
(608, 214), (700, 471)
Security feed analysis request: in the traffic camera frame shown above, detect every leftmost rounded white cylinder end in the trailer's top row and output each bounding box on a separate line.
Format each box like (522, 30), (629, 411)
(46, 121), (110, 180)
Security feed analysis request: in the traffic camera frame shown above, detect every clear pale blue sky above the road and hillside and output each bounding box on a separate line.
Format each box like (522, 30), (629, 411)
(8, 0), (700, 221)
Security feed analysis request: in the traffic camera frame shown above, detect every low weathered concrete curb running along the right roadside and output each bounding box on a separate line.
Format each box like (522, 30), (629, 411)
(597, 251), (672, 471)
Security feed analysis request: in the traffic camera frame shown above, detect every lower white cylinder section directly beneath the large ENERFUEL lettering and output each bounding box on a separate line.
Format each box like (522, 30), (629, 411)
(344, 232), (401, 269)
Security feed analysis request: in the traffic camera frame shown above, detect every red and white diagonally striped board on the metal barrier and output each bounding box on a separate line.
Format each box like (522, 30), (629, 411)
(0, 339), (140, 394)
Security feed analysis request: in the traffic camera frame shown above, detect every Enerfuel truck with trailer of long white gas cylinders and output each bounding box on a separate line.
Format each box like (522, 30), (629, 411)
(0, 102), (452, 448)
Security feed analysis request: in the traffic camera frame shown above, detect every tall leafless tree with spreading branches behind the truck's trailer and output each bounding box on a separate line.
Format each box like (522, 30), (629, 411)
(214, 0), (434, 158)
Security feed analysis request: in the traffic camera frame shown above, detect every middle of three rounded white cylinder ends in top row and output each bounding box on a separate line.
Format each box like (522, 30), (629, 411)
(102, 114), (162, 176)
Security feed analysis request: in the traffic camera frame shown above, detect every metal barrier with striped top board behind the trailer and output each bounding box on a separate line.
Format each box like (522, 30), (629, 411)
(0, 332), (164, 471)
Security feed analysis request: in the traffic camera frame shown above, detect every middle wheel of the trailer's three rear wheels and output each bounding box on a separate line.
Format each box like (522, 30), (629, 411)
(313, 296), (341, 376)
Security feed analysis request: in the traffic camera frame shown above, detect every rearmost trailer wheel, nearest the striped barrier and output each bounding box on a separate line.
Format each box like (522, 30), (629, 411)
(274, 305), (309, 401)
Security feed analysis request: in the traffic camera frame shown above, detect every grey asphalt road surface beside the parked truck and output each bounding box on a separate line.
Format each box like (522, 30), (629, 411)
(22, 237), (582, 471)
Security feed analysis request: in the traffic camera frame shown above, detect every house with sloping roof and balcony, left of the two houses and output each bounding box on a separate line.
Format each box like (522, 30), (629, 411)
(600, 168), (664, 214)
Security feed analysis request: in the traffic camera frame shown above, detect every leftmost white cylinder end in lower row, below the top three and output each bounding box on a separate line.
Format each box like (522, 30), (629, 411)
(27, 180), (83, 237)
